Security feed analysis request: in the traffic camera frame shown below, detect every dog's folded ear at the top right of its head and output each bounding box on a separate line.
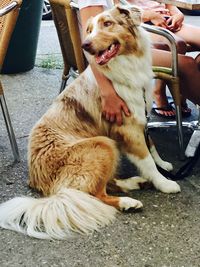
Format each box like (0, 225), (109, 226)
(113, 5), (142, 28)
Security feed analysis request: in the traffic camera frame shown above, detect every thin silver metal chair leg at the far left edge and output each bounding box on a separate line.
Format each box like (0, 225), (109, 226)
(0, 94), (20, 162)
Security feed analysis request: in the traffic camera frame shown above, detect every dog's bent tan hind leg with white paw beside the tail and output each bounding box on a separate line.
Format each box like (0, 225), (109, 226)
(58, 136), (142, 213)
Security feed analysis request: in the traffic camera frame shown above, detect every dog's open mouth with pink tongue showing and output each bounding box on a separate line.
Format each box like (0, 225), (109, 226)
(95, 43), (120, 65)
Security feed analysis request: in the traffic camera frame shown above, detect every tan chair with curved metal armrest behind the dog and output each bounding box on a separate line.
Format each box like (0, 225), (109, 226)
(50, 0), (184, 158)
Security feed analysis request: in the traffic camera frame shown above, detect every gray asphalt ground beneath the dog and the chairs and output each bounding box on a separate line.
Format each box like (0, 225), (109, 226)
(0, 14), (200, 267)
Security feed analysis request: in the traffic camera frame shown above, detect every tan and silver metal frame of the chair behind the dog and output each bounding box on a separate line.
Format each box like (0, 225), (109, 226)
(50, 0), (184, 159)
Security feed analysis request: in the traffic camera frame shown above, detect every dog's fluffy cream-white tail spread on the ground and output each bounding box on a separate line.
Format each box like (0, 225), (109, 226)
(0, 189), (117, 239)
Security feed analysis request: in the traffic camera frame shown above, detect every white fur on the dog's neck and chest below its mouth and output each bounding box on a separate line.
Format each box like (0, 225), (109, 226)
(104, 55), (153, 124)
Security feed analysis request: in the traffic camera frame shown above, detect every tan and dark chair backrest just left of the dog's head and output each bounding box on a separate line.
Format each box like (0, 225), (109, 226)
(49, 0), (87, 92)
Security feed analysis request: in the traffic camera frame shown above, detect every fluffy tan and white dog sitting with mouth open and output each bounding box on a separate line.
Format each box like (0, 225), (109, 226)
(0, 6), (180, 239)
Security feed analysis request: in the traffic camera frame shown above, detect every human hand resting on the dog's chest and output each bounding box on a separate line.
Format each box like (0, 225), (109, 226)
(101, 92), (130, 126)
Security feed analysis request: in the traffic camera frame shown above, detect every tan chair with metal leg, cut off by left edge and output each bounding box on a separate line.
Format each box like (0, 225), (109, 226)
(0, 0), (22, 162)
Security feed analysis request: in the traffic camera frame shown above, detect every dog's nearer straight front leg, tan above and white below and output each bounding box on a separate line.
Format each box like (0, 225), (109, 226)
(112, 124), (180, 193)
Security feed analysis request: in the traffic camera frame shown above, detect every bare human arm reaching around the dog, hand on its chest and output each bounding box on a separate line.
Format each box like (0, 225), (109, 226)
(80, 6), (130, 125)
